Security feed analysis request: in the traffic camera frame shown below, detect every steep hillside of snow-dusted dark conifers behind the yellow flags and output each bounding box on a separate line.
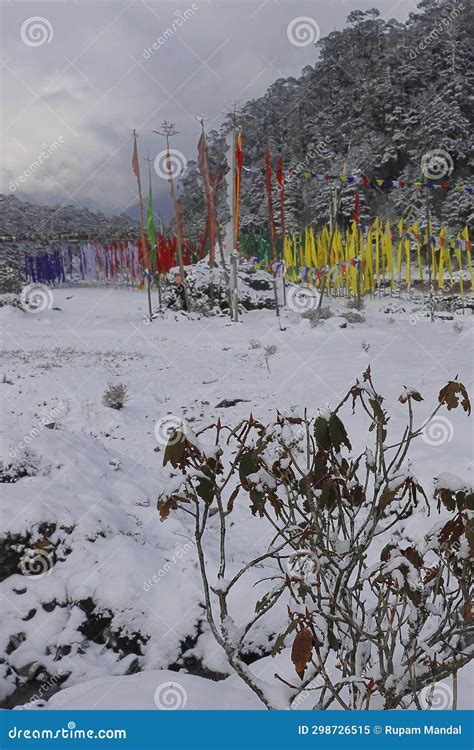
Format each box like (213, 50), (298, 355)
(181, 0), (473, 237)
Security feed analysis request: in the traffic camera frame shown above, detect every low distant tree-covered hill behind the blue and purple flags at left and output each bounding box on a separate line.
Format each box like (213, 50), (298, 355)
(0, 194), (138, 239)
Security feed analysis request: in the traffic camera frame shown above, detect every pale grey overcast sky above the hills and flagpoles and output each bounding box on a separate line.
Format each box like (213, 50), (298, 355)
(0, 0), (416, 213)
